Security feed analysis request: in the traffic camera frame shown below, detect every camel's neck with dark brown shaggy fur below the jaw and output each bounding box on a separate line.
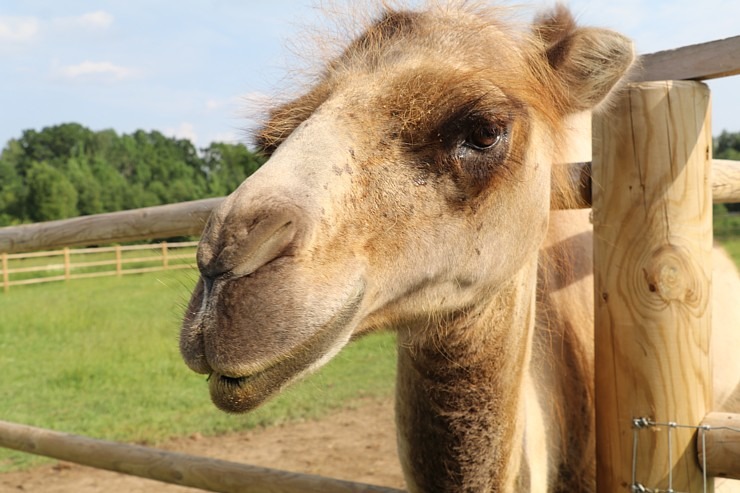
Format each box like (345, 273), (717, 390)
(396, 260), (536, 492)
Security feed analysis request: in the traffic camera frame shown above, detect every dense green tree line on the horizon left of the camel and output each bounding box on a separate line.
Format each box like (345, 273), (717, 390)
(0, 123), (264, 226)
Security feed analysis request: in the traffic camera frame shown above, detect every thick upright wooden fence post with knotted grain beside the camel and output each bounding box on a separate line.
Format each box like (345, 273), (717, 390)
(593, 82), (713, 493)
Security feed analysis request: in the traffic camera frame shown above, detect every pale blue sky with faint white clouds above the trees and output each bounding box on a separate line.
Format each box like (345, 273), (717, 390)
(0, 0), (740, 147)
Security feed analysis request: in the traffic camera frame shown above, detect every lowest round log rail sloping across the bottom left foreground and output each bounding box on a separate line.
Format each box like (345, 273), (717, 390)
(0, 421), (400, 493)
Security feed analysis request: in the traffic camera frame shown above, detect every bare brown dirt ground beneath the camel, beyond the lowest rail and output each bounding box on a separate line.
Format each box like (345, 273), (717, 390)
(0, 399), (404, 493)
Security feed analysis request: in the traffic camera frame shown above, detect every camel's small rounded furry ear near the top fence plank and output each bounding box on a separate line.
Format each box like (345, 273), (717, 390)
(534, 5), (635, 112)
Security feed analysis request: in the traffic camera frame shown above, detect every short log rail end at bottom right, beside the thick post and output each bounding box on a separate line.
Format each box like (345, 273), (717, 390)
(696, 412), (740, 479)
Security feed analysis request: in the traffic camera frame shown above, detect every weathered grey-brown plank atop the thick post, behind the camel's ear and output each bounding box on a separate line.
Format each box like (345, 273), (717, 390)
(634, 36), (740, 81)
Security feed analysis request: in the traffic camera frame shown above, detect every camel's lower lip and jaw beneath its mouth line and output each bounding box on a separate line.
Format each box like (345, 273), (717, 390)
(208, 287), (364, 413)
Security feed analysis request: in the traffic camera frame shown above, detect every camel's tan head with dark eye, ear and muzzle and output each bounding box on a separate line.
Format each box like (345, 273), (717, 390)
(180, 6), (633, 412)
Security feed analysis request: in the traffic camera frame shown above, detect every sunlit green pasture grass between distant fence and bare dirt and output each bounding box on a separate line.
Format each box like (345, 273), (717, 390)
(0, 271), (395, 472)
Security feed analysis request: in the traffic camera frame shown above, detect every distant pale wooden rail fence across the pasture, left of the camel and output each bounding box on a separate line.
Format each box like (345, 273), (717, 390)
(0, 241), (198, 292)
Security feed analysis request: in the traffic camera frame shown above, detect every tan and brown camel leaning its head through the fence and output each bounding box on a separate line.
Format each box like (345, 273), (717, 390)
(180, 2), (740, 493)
